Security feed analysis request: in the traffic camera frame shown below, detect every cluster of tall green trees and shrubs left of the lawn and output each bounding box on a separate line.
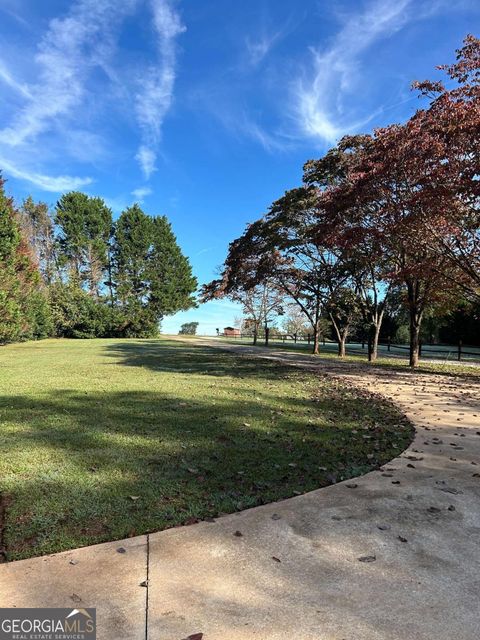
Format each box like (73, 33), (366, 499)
(0, 181), (197, 343)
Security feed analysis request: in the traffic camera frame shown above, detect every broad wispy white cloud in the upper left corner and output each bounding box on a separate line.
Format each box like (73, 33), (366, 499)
(0, 0), (137, 191)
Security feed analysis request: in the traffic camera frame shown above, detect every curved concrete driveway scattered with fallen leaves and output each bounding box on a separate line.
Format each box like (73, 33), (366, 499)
(0, 342), (480, 640)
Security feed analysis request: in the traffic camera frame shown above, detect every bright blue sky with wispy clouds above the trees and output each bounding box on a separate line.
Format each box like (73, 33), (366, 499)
(0, 0), (480, 333)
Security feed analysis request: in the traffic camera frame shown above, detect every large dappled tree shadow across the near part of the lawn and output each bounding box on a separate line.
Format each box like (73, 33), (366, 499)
(0, 380), (413, 559)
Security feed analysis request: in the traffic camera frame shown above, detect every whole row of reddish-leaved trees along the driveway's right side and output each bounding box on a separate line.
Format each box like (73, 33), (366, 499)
(202, 36), (480, 366)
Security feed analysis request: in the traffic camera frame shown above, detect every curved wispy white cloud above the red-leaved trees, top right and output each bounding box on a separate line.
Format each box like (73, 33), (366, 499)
(293, 0), (412, 143)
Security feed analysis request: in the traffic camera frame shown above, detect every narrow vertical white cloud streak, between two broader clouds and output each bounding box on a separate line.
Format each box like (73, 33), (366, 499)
(135, 0), (185, 179)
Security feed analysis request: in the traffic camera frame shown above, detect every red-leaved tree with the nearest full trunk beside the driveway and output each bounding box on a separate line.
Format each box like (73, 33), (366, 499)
(328, 119), (455, 367)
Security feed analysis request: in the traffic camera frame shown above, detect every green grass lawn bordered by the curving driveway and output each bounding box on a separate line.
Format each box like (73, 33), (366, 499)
(0, 339), (413, 560)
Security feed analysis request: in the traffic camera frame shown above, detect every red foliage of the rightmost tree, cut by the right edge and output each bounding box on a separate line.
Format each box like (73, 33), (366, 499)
(410, 35), (480, 301)
